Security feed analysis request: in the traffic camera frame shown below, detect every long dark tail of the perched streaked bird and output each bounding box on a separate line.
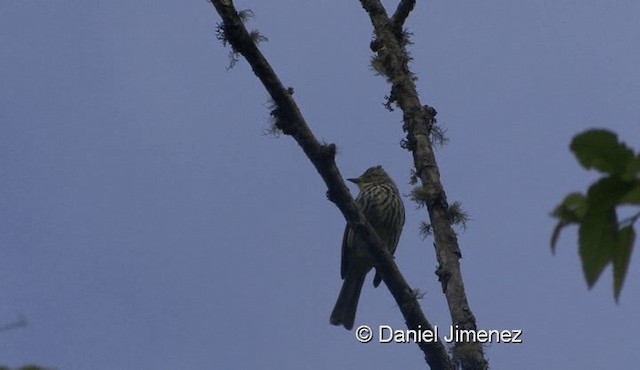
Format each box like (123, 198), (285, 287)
(330, 270), (367, 330)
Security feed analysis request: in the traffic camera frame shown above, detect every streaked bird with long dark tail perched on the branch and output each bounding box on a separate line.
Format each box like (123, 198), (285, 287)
(330, 166), (404, 330)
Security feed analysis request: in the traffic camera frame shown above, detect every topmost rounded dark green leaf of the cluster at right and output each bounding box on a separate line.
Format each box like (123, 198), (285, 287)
(570, 130), (634, 175)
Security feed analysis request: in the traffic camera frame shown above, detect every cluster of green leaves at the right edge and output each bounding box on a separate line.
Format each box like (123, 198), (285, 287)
(551, 130), (640, 301)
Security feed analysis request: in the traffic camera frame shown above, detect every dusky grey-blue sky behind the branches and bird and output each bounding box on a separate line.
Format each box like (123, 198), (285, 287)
(0, 0), (640, 369)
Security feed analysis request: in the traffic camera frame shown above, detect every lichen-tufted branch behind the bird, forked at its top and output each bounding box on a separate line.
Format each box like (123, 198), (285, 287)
(360, 0), (488, 369)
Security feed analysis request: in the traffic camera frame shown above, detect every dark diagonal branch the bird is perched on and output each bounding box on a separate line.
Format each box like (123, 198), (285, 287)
(210, 0), (453, 369)
